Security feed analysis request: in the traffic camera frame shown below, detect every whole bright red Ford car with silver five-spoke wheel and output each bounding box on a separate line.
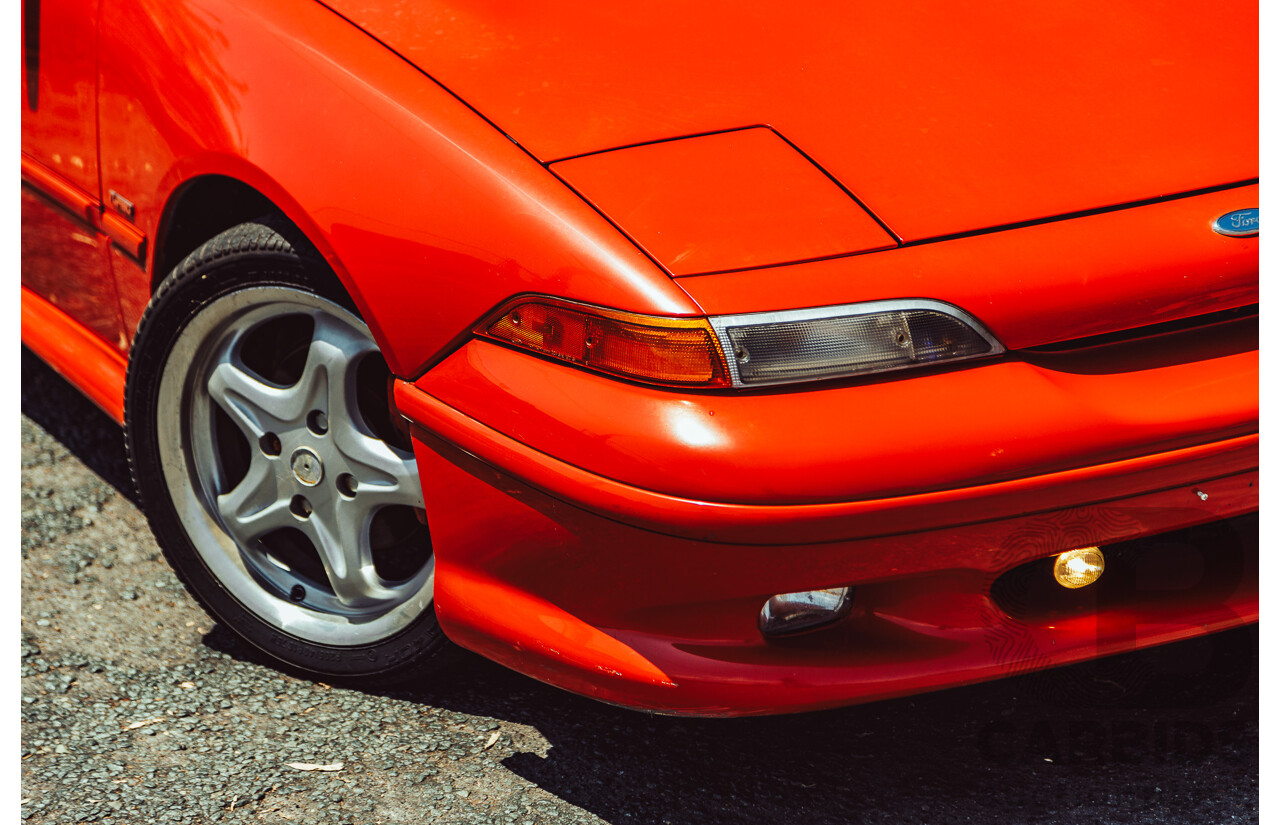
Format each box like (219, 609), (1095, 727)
(22, 0), (1258, 715)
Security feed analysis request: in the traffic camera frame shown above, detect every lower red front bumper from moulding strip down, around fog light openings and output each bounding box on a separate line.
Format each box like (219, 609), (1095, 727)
(396, 384), (1258, 715)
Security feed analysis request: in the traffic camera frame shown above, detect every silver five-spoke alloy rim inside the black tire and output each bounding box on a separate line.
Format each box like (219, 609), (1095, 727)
(157, 285), (434, 646)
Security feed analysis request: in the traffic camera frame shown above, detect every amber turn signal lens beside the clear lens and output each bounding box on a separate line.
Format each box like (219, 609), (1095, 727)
(477, 298), (730, 386)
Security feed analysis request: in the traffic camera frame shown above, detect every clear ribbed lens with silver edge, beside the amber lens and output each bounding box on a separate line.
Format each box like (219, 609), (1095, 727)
(710, 299), (1004, 386)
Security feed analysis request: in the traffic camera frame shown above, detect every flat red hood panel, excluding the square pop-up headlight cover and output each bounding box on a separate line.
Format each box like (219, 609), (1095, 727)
(330, 0), (1258, 240)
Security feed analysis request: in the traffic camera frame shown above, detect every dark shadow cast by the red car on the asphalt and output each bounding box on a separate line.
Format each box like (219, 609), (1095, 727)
(22, 349), (1258, 825)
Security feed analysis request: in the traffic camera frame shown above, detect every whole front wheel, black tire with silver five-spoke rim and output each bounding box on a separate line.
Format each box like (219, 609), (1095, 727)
(125, 216), (453, 686)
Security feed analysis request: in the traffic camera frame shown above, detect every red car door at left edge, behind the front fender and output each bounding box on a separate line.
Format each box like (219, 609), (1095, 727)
(22, 0), (128, 352)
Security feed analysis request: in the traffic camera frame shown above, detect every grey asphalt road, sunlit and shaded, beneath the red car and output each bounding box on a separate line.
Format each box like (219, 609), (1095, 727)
(22, 350), (1258, 825)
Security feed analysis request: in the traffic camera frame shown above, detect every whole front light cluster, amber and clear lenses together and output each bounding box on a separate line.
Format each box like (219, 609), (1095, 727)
(475, 295), (1005, 388)
